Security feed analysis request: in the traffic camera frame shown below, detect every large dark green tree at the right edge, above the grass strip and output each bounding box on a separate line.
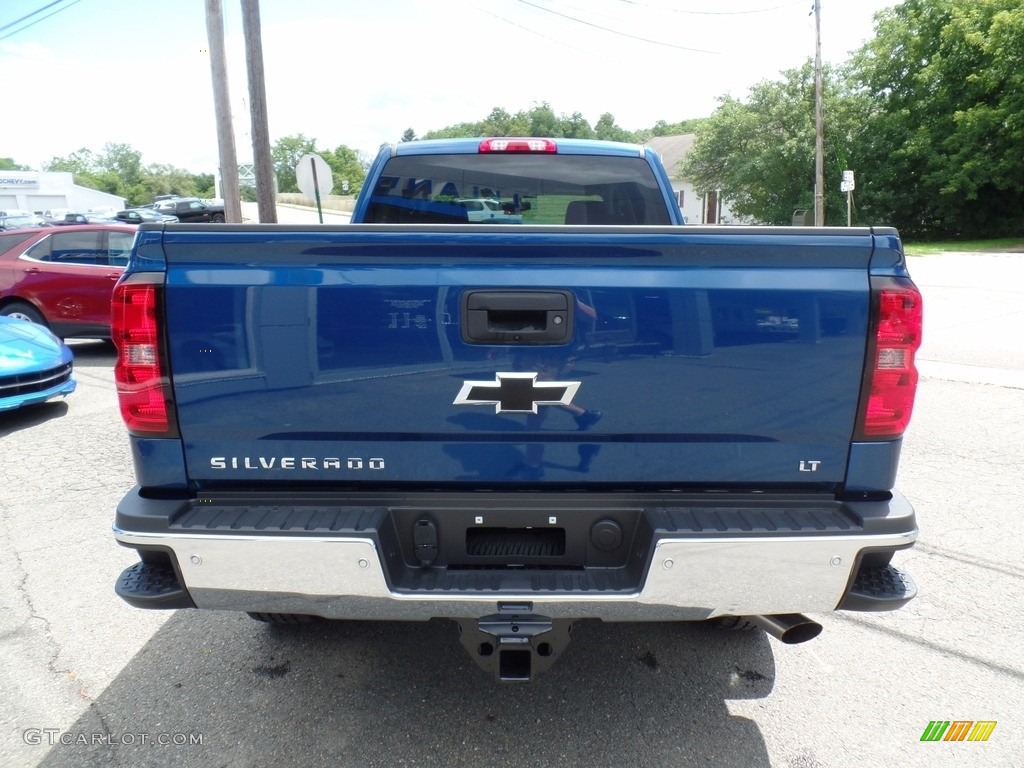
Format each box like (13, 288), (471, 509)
(853, 0), (1024, 238)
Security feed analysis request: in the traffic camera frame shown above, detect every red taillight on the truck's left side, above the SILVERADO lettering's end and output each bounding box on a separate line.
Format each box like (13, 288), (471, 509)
(111, 272), (177, 437)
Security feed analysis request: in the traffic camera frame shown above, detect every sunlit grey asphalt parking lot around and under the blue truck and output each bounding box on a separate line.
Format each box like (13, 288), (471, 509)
(0, 249), (1024, 768)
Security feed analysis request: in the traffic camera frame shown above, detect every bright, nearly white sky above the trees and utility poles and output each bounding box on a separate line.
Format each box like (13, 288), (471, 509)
(0, 0), (897, 173)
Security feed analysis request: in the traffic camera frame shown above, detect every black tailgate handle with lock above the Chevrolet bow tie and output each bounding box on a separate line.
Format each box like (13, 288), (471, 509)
(461, 290), (575, 345)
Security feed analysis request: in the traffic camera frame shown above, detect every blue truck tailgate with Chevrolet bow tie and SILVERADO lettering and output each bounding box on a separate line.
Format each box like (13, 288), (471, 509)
(163, 225), (872, 488)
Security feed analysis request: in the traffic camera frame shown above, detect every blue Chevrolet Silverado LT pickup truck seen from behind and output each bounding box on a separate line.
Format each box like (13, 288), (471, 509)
(113, 138), (922, 681)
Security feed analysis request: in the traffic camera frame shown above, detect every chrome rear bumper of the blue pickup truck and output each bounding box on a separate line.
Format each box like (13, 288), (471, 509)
(115, 496), (918, 622)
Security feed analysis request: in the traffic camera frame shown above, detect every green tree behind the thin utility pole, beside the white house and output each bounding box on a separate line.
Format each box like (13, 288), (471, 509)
(681, 60), (857, 224)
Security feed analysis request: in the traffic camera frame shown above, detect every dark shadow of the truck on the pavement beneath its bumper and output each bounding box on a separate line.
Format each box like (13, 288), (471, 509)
(40, 610), (775, 768)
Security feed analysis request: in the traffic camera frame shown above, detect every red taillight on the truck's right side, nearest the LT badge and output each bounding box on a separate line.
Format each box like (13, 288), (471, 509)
(857, 278), (924, 440)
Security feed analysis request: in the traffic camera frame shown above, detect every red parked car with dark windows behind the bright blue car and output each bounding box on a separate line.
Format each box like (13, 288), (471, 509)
(0, 224), (136, 338)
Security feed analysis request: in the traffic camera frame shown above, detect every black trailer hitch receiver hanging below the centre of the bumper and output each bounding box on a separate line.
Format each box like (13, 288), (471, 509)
(456, 603), (572, 683)
